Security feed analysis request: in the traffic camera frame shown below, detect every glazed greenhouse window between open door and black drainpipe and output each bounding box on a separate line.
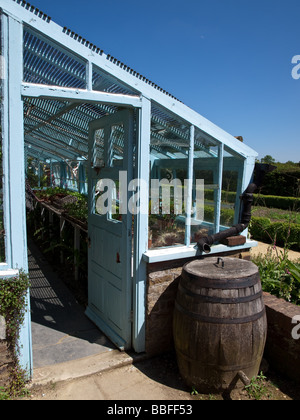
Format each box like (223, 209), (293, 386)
(148, 109), (243, 253)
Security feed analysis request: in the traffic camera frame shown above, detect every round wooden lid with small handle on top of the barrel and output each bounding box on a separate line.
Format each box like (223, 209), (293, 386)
(183, 257), (258, 280)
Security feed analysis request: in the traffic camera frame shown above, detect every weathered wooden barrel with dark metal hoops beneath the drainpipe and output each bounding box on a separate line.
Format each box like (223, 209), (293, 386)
(174, 258), (267, 393)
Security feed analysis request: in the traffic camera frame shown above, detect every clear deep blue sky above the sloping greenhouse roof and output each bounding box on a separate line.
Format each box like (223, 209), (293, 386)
(31, 0), (300, 162)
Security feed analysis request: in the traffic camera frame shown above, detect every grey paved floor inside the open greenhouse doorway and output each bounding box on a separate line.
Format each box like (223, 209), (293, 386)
(28, 240), (115, 368)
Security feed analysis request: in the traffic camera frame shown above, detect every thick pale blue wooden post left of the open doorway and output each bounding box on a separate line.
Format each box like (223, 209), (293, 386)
(1, 14), (32, 377)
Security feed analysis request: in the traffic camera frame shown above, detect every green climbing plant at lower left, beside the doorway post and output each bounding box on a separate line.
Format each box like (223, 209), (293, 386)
(0, 272), (30, 398)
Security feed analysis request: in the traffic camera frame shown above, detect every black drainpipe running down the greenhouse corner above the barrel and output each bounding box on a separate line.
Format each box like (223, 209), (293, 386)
(197, 164), (276, 254)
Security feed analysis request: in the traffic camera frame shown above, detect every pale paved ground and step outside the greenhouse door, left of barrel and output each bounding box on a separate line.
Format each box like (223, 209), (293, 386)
(29, 352), (193, 400)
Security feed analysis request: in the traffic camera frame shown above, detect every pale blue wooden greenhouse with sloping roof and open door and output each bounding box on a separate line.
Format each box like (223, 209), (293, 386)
(0, 0), (257, 376)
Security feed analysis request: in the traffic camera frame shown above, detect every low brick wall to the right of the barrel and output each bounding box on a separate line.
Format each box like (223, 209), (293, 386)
(264, 293), (300, 382)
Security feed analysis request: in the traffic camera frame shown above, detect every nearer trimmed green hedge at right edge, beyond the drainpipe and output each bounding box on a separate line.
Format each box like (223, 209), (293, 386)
(249, 217), (300, 251)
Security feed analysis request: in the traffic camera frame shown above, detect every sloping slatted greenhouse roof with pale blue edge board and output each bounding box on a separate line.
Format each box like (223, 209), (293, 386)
(0, 0), (257, 161)
